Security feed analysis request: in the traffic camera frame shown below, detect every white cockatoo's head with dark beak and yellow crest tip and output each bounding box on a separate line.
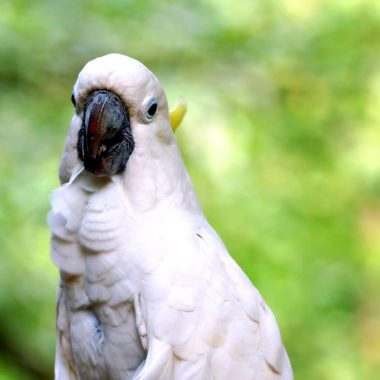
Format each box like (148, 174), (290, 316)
(72, 54), (185, 176)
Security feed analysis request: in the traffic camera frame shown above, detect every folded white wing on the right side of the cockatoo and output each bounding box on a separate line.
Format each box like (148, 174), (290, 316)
(133, 220), (292, 380)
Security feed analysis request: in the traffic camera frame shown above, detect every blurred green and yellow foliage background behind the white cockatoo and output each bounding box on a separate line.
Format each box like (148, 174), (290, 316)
(0, 0), (380, 380)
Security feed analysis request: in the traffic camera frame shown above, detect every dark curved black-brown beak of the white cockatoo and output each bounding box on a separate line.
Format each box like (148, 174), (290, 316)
(77, 90), (134, 176)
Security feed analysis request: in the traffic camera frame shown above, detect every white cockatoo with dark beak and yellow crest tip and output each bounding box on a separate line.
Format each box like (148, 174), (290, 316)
(48, 54), (293, 380)
